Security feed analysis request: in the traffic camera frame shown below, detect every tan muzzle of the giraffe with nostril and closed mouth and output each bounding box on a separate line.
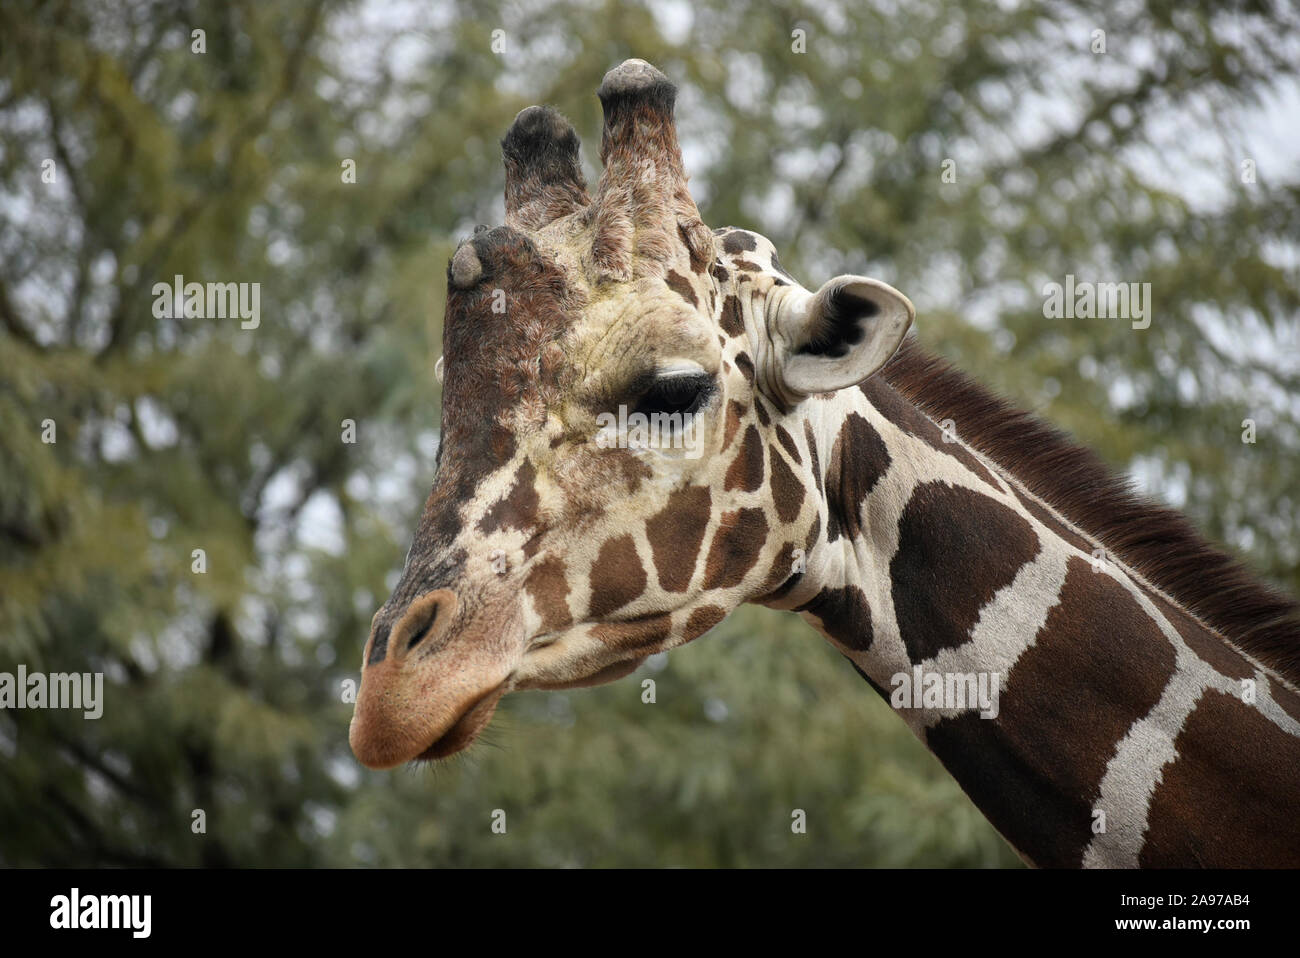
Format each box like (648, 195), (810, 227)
(348, 589), (514, 768)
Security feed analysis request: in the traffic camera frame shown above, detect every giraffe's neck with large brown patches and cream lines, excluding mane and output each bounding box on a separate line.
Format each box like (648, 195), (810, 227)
(764, 369), (1300, 867)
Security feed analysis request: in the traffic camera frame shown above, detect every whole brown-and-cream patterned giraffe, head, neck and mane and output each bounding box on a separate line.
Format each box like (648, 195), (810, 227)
(350, 60), (1300, 867)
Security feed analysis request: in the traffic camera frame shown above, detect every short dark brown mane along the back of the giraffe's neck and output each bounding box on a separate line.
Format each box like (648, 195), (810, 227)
(880, 335), (1300, 684)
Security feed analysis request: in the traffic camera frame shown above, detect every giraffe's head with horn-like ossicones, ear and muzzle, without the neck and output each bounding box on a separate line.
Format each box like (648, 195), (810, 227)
(351, 60), (913, 768)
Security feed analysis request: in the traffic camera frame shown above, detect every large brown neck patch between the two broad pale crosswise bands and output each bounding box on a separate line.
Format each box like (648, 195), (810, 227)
(926, 556), (1175, 868)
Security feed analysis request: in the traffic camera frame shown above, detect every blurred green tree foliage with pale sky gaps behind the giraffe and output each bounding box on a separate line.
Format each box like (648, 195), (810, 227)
(0, 0), (1300, 866)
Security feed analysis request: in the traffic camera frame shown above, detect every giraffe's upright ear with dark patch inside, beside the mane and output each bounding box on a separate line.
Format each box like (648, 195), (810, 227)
(772, 276), (917, 404)
